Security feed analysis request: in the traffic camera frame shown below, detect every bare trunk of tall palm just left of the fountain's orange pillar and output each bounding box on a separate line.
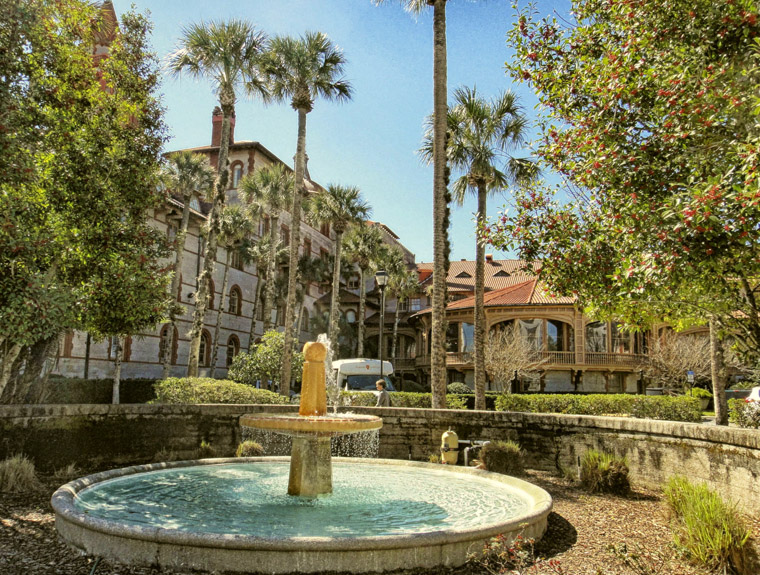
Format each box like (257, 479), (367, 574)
(280, 108), (306, 397)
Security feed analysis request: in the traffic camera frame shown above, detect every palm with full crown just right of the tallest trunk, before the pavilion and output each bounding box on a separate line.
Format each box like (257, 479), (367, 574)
(422, 87), (536, 409)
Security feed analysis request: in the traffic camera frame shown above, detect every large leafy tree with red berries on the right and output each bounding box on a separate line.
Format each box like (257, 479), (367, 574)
(485, 0), (760, 423)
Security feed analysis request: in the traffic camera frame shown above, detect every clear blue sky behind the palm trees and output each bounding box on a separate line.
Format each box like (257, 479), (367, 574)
(120, 0), (567, 262)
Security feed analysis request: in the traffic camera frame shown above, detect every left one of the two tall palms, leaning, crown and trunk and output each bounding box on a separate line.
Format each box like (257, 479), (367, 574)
(167, 20), (268, 377)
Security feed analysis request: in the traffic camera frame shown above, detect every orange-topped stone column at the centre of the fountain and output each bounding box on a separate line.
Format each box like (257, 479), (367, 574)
(288, 342), (332, 497)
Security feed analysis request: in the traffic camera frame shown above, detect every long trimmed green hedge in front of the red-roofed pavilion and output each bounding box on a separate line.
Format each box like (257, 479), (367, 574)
(496, 394), (702, 422)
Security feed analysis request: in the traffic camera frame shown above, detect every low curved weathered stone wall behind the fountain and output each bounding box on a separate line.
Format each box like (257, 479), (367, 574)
(0, 405), (760, 513)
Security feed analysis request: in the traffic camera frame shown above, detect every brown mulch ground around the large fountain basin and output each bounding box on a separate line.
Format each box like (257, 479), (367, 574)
(0, 472), (760, 575)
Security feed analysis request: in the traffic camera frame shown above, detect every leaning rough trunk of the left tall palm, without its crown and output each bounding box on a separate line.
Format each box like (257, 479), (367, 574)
(187, 94), (235, 377)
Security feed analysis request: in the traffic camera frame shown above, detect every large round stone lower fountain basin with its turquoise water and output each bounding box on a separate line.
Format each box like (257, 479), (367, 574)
(52, 457), (552, 573)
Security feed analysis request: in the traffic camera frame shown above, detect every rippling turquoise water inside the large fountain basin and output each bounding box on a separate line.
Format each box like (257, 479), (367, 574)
(75, 462), (528, 538)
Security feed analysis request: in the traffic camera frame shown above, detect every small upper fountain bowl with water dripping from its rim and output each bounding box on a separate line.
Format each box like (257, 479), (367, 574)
(240, 413), (383, 434)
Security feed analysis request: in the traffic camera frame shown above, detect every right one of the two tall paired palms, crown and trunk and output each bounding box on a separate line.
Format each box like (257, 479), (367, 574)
(266, 32), (351, 396)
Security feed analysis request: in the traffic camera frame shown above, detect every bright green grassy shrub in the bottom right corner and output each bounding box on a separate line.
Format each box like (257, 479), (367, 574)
(665, 476), (756, 574)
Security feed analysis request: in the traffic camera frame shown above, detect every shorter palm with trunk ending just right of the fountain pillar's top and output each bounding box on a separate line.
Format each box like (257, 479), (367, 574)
(310, 184), (370, 351)
